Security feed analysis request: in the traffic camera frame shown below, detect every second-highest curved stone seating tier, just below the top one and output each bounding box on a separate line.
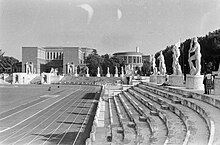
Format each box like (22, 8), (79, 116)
(138, 84), (213, 144)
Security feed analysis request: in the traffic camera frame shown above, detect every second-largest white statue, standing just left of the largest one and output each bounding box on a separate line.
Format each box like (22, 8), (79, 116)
(172, 45), (182, 75)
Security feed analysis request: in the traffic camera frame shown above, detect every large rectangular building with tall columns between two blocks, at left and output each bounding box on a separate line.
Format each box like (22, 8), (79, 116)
(22, 47), (95, 74)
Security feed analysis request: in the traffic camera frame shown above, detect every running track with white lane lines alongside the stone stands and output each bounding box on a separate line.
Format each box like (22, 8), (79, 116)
(0, 86), (100, 145)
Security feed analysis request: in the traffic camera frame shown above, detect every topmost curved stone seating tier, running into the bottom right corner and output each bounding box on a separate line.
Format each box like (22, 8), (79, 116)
(141, 83), (220, 144)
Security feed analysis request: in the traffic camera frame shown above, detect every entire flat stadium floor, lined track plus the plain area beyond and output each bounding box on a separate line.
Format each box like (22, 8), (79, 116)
(0, 85), (100, 145)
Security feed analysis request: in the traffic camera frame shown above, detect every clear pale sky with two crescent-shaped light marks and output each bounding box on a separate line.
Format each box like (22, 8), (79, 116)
(0, 0), (220, 60)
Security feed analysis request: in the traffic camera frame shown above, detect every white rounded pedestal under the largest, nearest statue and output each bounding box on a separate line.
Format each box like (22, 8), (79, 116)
(186, 75), (204, 90)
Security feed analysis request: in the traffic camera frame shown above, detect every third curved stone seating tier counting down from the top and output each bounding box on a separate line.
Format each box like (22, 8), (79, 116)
(128, 87), (186, 144)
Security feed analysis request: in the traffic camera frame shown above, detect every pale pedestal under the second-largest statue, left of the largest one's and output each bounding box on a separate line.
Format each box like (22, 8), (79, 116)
(169, 75), (184, 87)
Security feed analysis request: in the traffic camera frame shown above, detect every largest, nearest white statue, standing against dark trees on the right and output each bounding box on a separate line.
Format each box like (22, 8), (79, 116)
(188, 37), (201, 75)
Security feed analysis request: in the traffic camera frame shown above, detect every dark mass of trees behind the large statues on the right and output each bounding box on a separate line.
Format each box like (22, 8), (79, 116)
(155, 29), (220, 74)
